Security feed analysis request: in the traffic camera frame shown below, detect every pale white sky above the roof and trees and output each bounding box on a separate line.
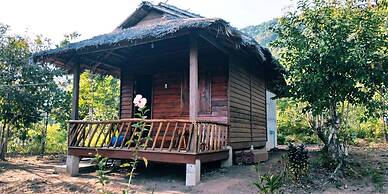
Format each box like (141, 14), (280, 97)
(0, 0), (292, 43)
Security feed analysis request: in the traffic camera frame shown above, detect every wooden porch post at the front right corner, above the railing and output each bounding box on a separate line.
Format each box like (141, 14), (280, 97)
(189, 34), (199, 120)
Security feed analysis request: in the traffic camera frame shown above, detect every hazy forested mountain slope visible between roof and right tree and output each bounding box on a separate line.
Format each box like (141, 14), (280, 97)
(241, 19), (278, 47)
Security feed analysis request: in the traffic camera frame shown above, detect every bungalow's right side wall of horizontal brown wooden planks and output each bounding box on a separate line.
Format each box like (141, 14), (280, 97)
(229, 56), (267, 149)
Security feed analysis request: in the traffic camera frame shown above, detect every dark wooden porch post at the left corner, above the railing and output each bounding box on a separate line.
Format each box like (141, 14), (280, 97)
(71, 62), (81, 120)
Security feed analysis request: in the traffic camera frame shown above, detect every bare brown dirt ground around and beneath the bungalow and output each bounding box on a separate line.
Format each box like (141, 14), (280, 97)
(0, 147), (388, 194)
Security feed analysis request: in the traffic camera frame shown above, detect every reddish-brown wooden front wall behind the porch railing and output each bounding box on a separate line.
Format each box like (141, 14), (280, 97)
(120, 55), (228, 123)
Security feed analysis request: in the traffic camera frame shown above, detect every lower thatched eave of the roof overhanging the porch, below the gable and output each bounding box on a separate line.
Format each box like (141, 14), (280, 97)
(32, 18), (285, 93)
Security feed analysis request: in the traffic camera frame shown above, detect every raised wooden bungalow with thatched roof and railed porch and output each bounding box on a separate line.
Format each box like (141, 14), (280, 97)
(32, 2), (284, 185)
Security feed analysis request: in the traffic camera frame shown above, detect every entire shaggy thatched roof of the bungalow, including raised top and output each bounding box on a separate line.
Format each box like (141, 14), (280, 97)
(32, 3), (283, 92)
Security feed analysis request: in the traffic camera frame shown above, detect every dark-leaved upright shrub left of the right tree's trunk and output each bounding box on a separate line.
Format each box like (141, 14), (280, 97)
(286, 144), (309, 182)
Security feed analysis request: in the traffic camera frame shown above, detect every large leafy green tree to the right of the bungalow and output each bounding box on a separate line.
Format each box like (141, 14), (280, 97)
(274, 0), (388, 166)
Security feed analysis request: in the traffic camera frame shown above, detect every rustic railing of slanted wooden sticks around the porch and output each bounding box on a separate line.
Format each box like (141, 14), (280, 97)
(68, 119), (228, 153)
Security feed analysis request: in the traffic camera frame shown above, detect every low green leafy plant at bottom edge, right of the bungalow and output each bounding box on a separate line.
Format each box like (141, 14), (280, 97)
(253, 164), (283, 194)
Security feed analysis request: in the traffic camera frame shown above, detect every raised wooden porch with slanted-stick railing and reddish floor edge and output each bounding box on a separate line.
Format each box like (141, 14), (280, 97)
(68, 119), (228, 164)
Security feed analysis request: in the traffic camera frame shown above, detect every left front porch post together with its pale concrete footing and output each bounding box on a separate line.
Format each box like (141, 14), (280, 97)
(66, 63), (81, 176)
